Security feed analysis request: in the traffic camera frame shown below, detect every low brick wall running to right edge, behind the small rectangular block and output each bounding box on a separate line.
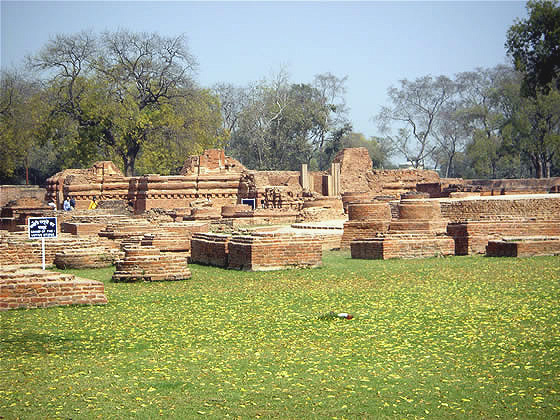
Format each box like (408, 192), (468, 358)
(447, 220), (560, 255)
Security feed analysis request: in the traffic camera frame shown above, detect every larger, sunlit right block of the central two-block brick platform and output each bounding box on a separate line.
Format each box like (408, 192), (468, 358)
(228, 233), (323, 271)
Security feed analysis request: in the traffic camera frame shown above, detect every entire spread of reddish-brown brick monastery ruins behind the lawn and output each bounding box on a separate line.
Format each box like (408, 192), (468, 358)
(0, 148), (560, 310)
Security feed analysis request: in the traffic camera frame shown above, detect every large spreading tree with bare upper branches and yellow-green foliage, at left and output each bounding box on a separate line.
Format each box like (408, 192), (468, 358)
(30, 30), (221, 176)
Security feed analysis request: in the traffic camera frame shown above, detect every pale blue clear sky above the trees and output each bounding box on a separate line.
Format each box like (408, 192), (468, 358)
(0, 0), (526, 136)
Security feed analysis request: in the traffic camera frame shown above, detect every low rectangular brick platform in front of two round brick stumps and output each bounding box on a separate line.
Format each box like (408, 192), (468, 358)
(350, 235), (455, 260)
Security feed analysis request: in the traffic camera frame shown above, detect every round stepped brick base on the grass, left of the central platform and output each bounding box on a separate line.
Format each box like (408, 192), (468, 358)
(113, 246), (191, 282)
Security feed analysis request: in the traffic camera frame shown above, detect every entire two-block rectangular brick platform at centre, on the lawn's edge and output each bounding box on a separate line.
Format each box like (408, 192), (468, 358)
(191, 232), (322, 271)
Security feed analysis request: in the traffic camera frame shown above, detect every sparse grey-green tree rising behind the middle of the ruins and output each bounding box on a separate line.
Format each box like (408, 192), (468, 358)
(228, 71), (351, 170)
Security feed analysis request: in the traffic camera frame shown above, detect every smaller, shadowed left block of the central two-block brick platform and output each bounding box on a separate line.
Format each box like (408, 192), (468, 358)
(190, 233), (231, 268)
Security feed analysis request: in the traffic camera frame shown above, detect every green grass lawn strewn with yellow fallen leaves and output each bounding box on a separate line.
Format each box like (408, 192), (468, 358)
(0, 252), (560, 419)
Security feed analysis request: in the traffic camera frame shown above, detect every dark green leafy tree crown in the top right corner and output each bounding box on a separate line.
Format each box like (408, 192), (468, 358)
(506, 0), (560, 96)
